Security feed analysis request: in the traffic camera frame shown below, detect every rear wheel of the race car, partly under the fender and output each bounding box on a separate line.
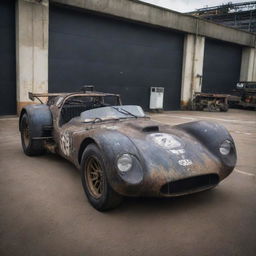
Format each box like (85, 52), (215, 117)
(20, 114), (44, 156)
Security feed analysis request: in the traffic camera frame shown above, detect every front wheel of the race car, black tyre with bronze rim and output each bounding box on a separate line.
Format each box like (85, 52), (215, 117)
(81, 144), (122, 211)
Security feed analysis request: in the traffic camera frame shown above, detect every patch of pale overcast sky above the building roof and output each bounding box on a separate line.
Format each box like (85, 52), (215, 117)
(141, 0), (253, 12)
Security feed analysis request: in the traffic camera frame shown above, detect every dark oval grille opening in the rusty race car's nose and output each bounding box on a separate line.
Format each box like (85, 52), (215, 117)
(161, 174), (219, 195)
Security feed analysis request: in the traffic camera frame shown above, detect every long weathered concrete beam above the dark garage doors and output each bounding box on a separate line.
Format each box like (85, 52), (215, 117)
(50, 0), (256, 47)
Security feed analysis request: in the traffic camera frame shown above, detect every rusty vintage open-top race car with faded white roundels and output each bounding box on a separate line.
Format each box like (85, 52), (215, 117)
(19, 88), (237, 211)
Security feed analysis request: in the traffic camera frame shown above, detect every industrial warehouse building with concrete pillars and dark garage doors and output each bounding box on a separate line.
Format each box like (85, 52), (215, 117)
(0, 0), (256, 115)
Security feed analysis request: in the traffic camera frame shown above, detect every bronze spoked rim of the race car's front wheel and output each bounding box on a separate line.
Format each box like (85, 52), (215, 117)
(85, 156), (104, 199)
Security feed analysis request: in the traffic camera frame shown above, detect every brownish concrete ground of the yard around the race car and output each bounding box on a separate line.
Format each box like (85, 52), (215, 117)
(0, 109), (256, 256)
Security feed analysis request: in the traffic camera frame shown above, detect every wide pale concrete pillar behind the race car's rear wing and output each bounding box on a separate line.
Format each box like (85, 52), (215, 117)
(16, 0), (49, 113)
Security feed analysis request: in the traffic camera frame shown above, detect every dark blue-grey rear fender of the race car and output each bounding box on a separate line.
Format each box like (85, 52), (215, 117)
(19, 104), (52, 139)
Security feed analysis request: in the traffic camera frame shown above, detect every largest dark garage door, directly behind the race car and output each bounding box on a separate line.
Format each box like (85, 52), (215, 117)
(49, 5), (184, 110)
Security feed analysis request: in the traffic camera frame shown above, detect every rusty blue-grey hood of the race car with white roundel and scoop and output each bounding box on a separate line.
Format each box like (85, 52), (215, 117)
(97, 119), (221, 180)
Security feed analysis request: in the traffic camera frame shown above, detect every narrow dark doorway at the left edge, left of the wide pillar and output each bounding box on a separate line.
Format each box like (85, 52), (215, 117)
(0, 0), (16, 115)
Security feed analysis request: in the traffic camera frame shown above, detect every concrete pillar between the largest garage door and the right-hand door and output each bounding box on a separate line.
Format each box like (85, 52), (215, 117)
(181, 34), (205, 108)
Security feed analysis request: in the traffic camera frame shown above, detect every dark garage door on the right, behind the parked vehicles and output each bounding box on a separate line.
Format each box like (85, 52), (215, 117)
(202, 39), (242, 93)
